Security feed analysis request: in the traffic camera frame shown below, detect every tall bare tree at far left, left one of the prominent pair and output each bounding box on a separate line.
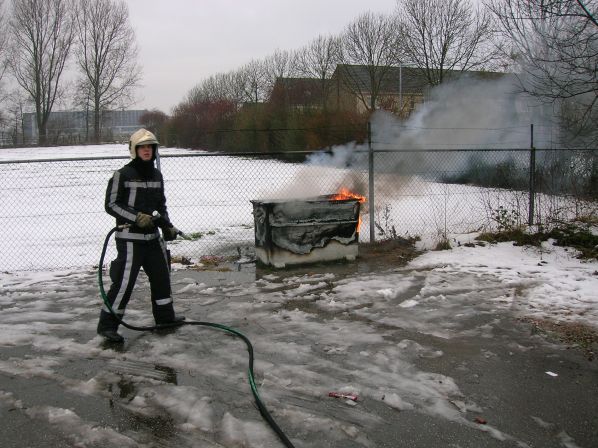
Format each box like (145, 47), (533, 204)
(9, 0), (73, 145)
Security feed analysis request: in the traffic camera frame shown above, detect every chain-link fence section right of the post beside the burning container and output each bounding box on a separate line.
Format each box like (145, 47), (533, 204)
(374, 149), (598, 242)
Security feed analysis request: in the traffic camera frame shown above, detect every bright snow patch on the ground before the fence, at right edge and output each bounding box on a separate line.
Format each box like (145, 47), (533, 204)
(411, 241), (598, 329)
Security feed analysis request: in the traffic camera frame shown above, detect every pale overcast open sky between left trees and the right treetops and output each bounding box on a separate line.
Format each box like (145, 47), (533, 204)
(126, 0), (396, 113)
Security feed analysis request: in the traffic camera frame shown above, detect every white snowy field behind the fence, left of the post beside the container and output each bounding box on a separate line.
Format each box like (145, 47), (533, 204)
(0, 144), (364, 271)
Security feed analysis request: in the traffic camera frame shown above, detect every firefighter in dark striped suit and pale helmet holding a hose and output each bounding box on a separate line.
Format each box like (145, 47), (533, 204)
(97, 129), (185, 343)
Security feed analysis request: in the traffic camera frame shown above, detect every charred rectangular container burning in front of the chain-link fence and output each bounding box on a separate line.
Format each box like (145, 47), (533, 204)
(251, 193), (365, 268)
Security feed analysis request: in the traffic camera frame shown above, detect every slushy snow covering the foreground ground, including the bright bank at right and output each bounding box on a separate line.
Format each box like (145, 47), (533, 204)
(0, 243), (598, 448)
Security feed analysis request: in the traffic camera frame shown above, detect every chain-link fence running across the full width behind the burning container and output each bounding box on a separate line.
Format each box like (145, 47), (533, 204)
(0, 144), (598, 271)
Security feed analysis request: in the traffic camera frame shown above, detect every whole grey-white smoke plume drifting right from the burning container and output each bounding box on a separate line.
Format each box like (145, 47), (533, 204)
(276, 75), (553, 198)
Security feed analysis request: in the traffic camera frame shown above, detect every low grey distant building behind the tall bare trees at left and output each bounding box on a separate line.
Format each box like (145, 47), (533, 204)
(23, 110), (147, 144)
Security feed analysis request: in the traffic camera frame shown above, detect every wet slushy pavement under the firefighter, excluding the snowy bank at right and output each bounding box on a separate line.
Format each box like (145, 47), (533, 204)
(0, 259), (598, 448)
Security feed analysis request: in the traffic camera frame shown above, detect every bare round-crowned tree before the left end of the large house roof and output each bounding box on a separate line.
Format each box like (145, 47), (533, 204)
(342, 12), (404, 111)
